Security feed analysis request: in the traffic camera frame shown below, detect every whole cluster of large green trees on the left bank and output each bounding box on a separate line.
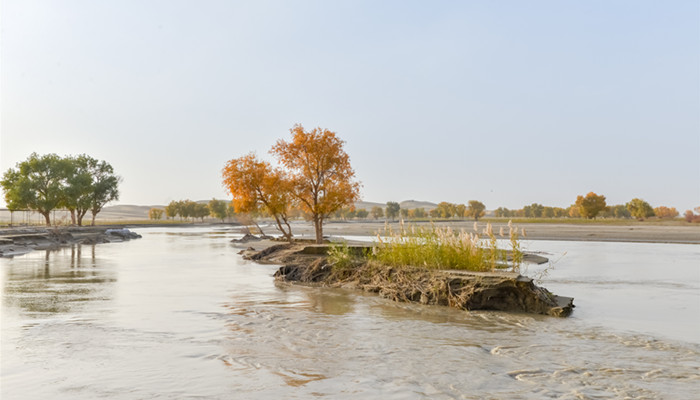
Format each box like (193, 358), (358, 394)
(0, 153), (121, 226)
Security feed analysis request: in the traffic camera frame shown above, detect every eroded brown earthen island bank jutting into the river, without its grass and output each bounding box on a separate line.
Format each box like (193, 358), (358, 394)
(241, 244), (574, 317)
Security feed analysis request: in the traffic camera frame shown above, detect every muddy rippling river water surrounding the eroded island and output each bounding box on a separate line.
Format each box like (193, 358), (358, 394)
(0, 229), (700, 400)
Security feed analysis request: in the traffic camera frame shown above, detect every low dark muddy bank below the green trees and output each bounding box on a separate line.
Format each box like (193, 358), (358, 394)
(0, 227), (141, 257)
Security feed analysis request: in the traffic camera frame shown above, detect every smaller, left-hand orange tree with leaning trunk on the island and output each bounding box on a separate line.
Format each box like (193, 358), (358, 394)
(221, 153), (292, 242)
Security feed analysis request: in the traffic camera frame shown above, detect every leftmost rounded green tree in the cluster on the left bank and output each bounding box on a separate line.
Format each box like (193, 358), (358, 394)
(0, 153), (68, 225)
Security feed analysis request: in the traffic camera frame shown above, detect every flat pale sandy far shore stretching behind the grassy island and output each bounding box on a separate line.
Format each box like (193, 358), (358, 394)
(280, 221), (700, 244)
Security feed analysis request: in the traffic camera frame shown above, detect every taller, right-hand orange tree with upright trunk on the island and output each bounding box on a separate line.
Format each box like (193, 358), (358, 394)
(270, 124), (360, 243)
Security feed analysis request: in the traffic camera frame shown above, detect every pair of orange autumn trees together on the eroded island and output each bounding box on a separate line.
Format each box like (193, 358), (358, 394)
(222, 125), (360, 243)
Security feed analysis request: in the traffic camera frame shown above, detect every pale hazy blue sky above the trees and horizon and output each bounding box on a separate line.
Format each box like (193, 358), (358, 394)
(0, 0), (700, 213)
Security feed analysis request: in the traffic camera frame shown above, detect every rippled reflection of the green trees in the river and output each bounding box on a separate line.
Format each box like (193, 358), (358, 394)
(3, 244), (117, 317)
